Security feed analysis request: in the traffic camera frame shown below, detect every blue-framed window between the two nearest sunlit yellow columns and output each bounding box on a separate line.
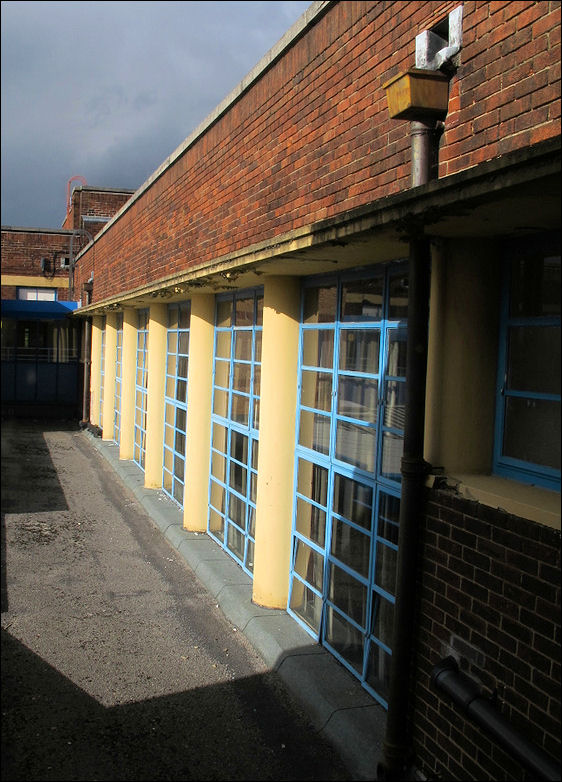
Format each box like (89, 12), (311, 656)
(208, 289), (263, 575)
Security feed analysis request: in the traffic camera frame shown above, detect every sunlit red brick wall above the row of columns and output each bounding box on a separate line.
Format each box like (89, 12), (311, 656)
(77, 0), (560, 301)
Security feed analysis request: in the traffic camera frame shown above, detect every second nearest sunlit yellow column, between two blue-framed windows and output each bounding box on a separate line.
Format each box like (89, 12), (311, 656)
(183, 293), (215, 532)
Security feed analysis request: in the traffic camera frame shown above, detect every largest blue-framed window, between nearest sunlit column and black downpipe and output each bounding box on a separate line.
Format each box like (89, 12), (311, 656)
(289, 264), (408, 705)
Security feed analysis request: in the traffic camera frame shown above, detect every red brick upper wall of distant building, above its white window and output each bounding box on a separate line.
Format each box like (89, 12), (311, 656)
(2, 230), (70, 301)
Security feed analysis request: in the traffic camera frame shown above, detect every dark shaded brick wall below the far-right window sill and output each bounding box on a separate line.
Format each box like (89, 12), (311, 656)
(412, 490), (560, 780)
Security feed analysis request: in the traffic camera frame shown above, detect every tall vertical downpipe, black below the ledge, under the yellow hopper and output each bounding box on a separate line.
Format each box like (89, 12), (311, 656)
(377, 117), (438, 780)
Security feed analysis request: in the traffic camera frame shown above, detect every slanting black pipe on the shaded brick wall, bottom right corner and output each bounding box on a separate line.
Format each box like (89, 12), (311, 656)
(431, 657), (561, 782)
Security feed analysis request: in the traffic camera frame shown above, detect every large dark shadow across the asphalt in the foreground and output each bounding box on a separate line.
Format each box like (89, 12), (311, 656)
(1, 630), (351, 782)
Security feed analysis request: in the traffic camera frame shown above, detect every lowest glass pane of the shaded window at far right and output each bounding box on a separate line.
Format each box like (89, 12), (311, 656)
(503, 397), (560, 470)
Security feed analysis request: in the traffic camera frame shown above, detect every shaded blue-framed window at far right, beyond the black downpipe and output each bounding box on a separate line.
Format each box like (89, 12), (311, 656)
(494, 242), (560, 491)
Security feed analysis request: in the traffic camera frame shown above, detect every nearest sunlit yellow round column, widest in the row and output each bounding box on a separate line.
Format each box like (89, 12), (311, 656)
(253, 277), (300, 608)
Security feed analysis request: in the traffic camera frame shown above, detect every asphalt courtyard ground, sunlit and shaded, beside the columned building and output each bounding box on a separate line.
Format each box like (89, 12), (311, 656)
(1, 419), (354, 782)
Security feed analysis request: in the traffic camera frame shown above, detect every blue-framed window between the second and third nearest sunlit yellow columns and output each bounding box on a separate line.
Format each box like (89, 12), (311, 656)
(162, 302), (191, 508)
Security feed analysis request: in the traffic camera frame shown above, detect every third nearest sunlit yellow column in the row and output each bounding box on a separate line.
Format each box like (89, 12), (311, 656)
(144, 304), (168, 489)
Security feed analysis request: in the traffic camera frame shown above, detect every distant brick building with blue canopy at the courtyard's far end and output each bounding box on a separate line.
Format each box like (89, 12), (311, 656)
(1, 186), (134, 416)
